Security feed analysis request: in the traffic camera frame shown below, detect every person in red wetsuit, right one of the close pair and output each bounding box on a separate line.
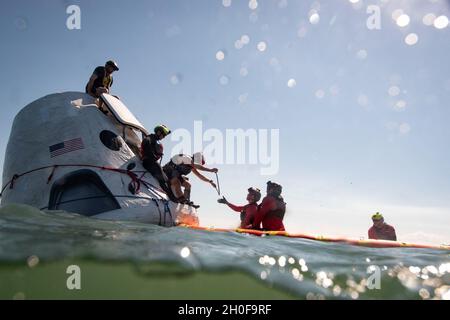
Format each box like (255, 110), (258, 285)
(252, 181), (286, 231)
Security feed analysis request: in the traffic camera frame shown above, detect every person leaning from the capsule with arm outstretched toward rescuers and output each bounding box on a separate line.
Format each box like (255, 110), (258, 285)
(163, 152), (219, 205)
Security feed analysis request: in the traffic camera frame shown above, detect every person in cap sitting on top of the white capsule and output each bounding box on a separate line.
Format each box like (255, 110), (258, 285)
(86, 60), (119, 98)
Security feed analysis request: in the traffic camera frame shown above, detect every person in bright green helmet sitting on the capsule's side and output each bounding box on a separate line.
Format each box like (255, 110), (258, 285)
(141, 124), (175, 200)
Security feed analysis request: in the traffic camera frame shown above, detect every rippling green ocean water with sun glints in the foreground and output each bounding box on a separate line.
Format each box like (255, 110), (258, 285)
(0, 205), (450, 299)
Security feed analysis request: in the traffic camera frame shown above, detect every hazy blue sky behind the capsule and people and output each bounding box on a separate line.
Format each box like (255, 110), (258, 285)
(0, 0), (450, 243)
